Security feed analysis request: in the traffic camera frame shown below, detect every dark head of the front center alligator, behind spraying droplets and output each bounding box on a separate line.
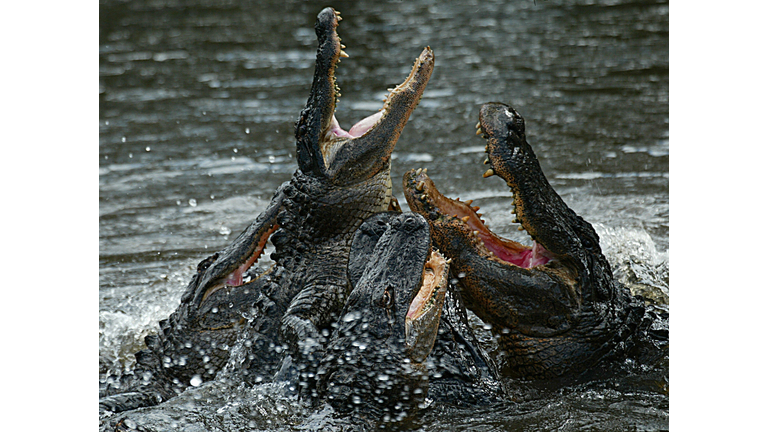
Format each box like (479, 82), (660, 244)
(317, 213), (448, 421)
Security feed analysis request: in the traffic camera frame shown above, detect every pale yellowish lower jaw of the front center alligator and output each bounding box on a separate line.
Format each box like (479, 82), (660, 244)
(405, 250), (450, 363)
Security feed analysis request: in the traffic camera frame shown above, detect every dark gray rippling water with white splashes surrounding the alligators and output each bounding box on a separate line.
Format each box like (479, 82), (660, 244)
(99, 0), (669, 430)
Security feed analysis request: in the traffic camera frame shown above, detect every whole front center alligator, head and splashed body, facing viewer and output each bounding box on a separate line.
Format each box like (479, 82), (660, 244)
(312, 212), (502, 424)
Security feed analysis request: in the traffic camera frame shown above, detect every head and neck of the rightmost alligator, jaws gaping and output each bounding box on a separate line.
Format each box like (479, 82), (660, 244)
(403, 103), (644, 379)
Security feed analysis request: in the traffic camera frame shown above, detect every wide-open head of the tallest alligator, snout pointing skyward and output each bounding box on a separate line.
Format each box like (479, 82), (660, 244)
(296, 8), (434, 183)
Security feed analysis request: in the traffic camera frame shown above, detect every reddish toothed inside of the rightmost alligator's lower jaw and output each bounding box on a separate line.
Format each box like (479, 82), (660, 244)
(403, 169), (555, 269)
